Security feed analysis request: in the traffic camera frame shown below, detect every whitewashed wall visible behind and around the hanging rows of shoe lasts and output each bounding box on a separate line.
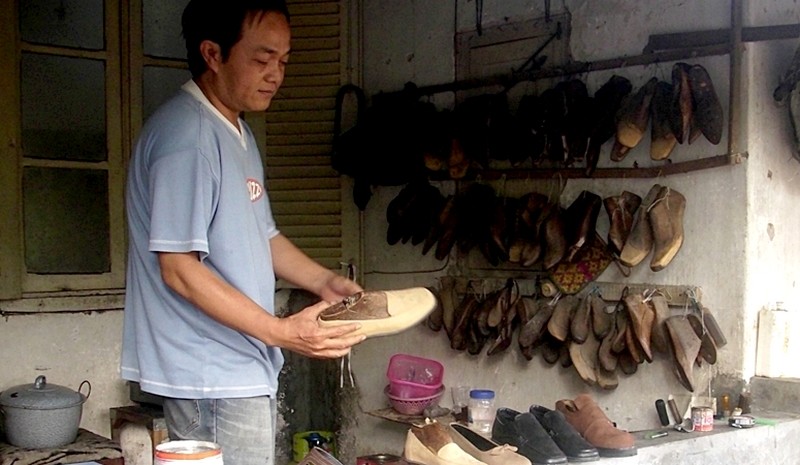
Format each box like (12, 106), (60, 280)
(353, 0), (800, 454)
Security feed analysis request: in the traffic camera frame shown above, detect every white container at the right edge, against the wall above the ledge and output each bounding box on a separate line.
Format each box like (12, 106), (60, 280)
(756, 302), (800, 378)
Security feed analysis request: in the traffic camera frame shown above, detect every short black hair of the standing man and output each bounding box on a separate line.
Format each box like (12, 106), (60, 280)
(181, 0), (289, 78)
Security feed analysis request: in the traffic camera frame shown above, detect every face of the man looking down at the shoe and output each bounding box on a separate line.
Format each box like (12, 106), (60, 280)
(216, 12), (291, 115)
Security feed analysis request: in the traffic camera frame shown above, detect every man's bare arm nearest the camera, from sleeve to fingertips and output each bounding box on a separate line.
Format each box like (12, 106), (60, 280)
(158, 252), (364, 358)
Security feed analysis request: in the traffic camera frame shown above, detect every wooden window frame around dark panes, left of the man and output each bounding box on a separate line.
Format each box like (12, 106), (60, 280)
(0, 0), (127, 304)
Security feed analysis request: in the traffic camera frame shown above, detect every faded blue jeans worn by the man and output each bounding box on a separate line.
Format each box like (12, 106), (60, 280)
(164, 396), (277, 465)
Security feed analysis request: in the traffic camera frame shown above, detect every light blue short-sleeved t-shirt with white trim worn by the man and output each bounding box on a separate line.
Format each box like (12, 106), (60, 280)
(121, 81), (283, 399)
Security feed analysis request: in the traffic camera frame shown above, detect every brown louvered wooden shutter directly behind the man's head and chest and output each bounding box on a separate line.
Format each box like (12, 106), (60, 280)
(266, 0), (342, 269)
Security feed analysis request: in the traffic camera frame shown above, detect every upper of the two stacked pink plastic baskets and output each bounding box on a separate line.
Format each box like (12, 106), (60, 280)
(386, 354), (444, 399)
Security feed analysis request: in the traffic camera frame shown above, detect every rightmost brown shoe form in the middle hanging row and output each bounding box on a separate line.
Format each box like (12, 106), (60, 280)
(648, 186), (686, 271)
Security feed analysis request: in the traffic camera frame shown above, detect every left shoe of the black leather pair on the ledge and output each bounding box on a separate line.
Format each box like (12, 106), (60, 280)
(492, 407), (567, 465)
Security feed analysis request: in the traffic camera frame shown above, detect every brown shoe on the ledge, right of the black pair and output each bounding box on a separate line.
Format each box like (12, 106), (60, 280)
(556, 394), (637, 457)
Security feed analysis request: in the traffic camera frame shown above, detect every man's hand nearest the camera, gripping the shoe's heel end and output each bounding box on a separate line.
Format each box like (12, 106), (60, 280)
(277, 298), (366, 358)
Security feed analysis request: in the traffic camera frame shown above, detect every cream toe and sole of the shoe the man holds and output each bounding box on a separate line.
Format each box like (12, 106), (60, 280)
(319, 287), (437, 337)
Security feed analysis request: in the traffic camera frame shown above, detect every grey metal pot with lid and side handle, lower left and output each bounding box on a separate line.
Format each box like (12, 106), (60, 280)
(0, 376), (92, 449)
